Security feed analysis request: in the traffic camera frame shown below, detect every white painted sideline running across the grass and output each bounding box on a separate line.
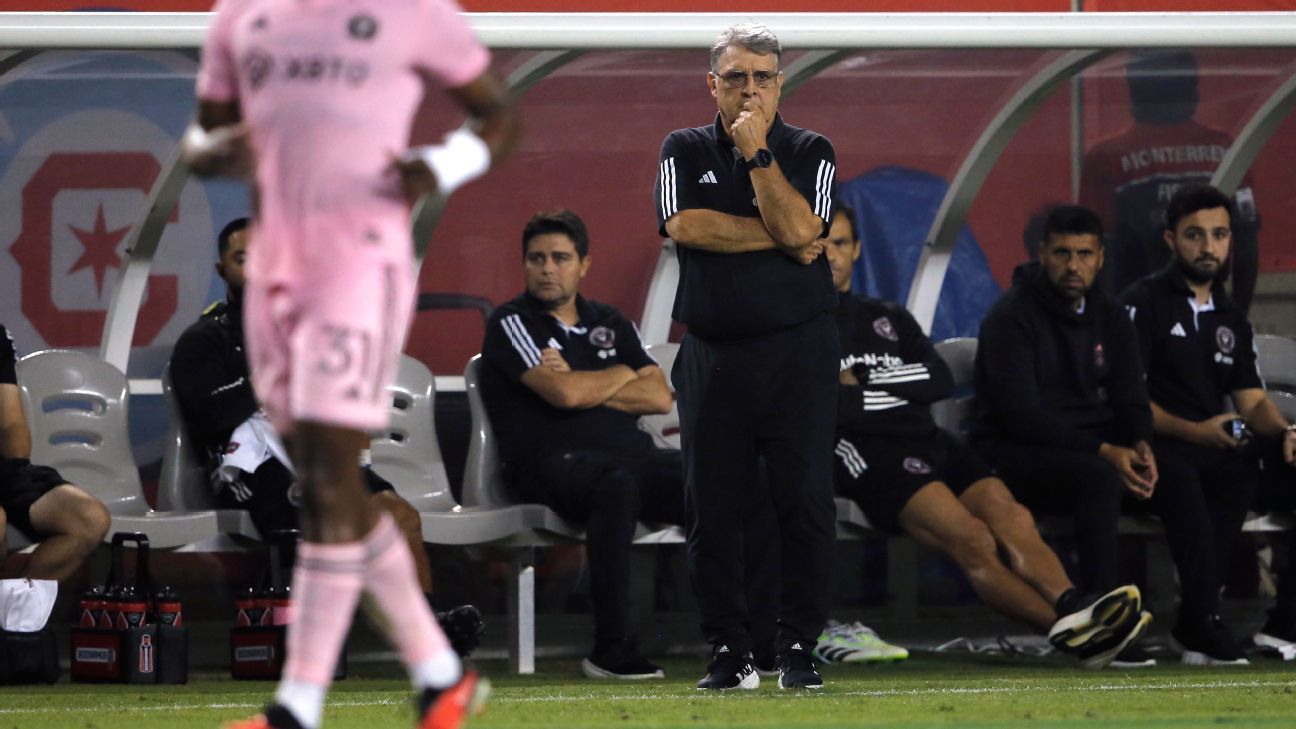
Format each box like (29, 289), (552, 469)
(0, 678), (1296, 715)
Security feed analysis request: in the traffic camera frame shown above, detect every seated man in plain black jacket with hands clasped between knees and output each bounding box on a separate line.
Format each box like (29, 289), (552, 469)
(972, 205), (1157, 653)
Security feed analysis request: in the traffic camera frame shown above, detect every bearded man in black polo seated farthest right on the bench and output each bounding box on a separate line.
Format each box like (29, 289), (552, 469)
(1121, 184), (1296, 664)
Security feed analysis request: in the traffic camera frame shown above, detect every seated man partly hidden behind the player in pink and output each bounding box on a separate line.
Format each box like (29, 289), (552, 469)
(171, 218), (432, 592)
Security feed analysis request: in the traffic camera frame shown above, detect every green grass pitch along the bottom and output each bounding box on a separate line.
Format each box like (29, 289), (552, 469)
(0, 654), (1296, 729)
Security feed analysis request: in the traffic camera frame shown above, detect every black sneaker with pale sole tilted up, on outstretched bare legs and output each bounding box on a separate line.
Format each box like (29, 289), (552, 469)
(1048, 585), (1152, 668)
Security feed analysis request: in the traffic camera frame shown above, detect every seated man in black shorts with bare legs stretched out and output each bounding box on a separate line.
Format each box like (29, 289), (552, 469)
(826, 208), (1143, 665)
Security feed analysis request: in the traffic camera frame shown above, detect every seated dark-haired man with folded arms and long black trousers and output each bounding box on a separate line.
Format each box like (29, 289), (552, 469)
(481, 210), (684, 678)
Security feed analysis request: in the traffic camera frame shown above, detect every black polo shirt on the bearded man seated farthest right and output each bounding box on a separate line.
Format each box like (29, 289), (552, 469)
(1121, 262), (1264, 422)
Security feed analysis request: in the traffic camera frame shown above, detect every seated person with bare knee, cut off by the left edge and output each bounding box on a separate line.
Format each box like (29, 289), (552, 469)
(0, 324), (110, 580)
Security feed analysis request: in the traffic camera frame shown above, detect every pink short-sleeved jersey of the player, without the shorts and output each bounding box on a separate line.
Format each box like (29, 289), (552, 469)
(198, 0), (490, 280)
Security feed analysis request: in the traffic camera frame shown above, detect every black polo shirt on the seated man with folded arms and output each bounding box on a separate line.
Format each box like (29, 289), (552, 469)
(481, 293), (657, 464)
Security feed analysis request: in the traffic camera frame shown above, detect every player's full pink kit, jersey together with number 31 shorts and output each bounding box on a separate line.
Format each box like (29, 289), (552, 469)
(198, 0), (490, 431)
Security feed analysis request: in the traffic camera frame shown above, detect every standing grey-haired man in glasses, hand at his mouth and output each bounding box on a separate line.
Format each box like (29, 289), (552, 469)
(656, 25), (839, 689)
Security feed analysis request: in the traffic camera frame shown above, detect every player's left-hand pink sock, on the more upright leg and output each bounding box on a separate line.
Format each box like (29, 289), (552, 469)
(284, 542), (365, 687)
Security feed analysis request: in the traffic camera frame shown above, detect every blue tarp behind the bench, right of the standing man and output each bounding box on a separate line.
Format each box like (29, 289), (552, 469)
(839, 167), (999, 341)
